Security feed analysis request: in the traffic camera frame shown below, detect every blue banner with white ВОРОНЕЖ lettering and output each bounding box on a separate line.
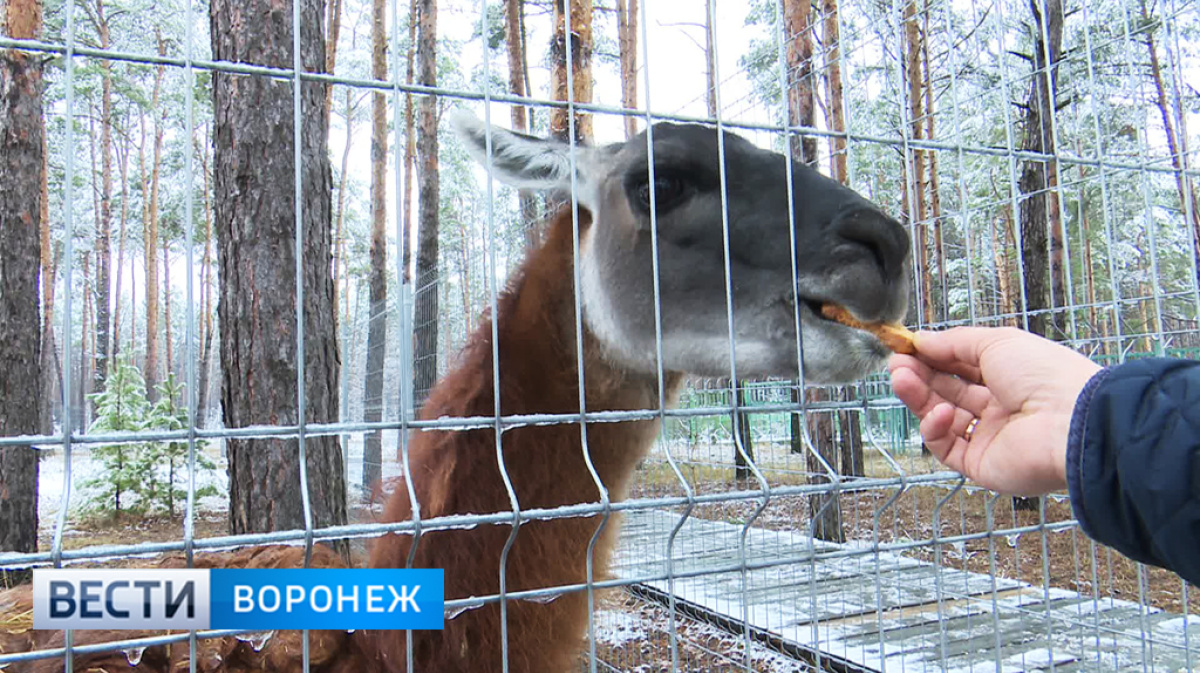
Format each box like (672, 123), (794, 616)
(210, 569), (445, 630)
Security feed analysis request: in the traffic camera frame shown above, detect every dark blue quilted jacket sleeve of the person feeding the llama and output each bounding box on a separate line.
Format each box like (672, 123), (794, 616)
(1067, 359), (1200, 583)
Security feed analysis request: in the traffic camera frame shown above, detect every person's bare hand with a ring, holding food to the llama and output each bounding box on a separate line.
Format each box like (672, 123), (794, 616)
(888, 328), (1100, 495)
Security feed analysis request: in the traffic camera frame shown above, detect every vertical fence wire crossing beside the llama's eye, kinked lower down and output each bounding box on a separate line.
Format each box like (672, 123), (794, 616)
(633, 2), (696, 671)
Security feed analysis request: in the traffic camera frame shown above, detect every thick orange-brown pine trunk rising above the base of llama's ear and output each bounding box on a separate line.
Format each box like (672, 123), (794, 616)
(550, 0), (593, 143)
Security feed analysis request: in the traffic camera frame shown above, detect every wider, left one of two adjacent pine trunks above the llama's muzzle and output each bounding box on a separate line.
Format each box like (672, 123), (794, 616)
(784, 0), (817, 166)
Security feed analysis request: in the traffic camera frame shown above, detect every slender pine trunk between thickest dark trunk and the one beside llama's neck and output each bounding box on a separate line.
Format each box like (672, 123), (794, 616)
(362, 0), (388, 491)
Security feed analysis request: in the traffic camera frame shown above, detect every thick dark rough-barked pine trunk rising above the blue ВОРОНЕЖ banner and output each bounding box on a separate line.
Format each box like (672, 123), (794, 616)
(210, 0), (347, 551)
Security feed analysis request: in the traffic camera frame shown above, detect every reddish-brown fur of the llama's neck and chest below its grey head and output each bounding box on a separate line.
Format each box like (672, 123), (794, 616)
(352, 211), (679, 673)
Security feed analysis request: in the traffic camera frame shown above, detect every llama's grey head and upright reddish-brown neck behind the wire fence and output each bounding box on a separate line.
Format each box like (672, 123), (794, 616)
(356, 114), (910, 673)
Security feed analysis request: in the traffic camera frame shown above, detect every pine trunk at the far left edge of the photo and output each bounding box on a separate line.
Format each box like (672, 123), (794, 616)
(0, 0), (44, 552)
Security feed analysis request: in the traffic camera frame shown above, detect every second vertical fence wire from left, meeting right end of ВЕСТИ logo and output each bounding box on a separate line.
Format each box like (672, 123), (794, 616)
(181, 0), (200, 673)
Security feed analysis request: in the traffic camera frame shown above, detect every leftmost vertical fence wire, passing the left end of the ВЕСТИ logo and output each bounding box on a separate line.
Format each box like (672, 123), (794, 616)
(50, 2), (80, 673)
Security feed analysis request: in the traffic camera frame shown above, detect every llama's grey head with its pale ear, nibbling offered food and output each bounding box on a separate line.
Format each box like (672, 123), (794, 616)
(452, 112), (910, 383)
